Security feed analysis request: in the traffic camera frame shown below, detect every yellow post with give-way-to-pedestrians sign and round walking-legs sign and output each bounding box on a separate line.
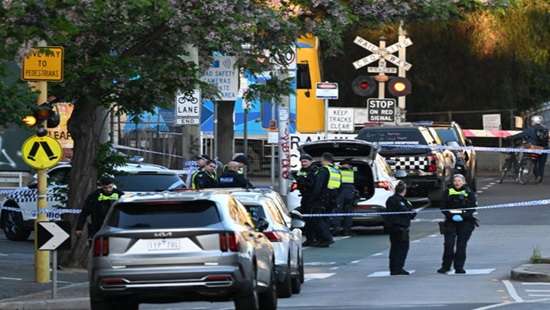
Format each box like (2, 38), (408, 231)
(21, 42), (64, 283)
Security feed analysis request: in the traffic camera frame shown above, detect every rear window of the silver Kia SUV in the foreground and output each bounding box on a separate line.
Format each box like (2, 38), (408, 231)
(107, 200), (221, 229)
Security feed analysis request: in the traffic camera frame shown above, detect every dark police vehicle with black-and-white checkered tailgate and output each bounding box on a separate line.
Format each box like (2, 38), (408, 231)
(357, 125), (454, 205)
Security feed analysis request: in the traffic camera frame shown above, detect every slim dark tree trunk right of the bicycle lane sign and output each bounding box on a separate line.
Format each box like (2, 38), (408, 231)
(218, 101), (235, 163)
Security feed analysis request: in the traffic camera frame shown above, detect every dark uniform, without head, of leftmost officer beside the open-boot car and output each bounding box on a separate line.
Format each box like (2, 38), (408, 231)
(294, 160), (317, 244)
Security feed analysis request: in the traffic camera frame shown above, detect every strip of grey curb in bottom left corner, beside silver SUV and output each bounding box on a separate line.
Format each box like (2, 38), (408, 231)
(0, 297), (90, 310)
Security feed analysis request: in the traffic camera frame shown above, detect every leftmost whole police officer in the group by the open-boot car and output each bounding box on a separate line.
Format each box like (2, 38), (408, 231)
(294, 154), (318, 246)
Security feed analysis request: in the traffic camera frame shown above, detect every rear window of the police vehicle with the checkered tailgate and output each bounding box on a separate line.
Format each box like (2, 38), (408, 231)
(357, 128), (427, 145)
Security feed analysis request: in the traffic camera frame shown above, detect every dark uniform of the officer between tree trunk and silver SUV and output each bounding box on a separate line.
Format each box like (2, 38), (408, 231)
(76, 189), (124, 238)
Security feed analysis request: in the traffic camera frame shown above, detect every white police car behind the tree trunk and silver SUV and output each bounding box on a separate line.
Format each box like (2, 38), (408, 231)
(0, 163), (185, 241)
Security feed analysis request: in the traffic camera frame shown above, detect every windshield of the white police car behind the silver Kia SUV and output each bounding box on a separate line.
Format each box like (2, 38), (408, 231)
(115, 173), (184, 192)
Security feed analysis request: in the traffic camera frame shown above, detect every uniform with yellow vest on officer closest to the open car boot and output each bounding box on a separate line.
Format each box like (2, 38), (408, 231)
(337, 163), (356, 234)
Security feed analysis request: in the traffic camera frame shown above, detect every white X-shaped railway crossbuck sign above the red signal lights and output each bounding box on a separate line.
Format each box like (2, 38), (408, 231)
(353, 36), (412, 73)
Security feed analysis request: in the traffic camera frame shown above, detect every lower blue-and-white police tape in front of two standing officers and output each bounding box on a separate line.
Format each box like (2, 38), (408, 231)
(302, 199), (550, 217)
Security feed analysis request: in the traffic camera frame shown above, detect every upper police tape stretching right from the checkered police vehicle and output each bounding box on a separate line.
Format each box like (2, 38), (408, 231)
(377, 143), (550, 154)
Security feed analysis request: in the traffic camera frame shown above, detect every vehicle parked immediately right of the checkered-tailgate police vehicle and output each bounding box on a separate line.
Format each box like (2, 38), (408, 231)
(430, 122), (477, 191)
